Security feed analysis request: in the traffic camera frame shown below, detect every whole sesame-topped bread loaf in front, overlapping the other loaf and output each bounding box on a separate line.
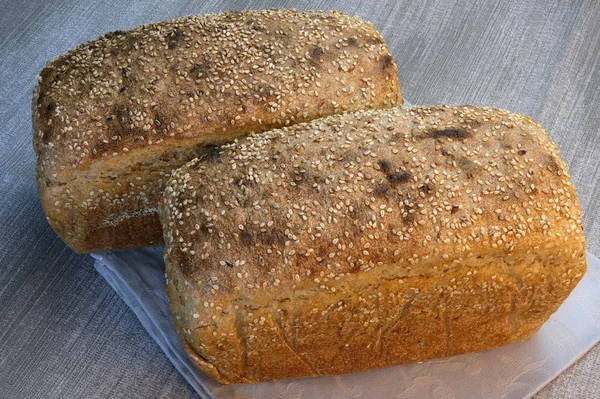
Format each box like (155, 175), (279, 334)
(161, 106), (586, 383)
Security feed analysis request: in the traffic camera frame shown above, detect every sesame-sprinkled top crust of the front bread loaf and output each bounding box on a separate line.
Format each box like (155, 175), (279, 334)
(161, 106), (583, 300)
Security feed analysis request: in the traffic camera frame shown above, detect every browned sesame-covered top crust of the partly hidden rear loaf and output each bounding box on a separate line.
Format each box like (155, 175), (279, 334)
(32, 10), (401, 181)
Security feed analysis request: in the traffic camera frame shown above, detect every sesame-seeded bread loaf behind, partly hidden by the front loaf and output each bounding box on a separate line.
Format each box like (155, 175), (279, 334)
(32, 10), (402, 253)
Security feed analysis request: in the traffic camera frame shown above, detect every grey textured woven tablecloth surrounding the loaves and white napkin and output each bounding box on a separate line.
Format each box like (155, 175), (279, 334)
(0, 0), (600, 399)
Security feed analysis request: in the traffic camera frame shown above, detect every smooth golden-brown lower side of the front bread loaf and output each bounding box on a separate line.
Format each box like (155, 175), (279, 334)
(167, 248), (585, 383)
